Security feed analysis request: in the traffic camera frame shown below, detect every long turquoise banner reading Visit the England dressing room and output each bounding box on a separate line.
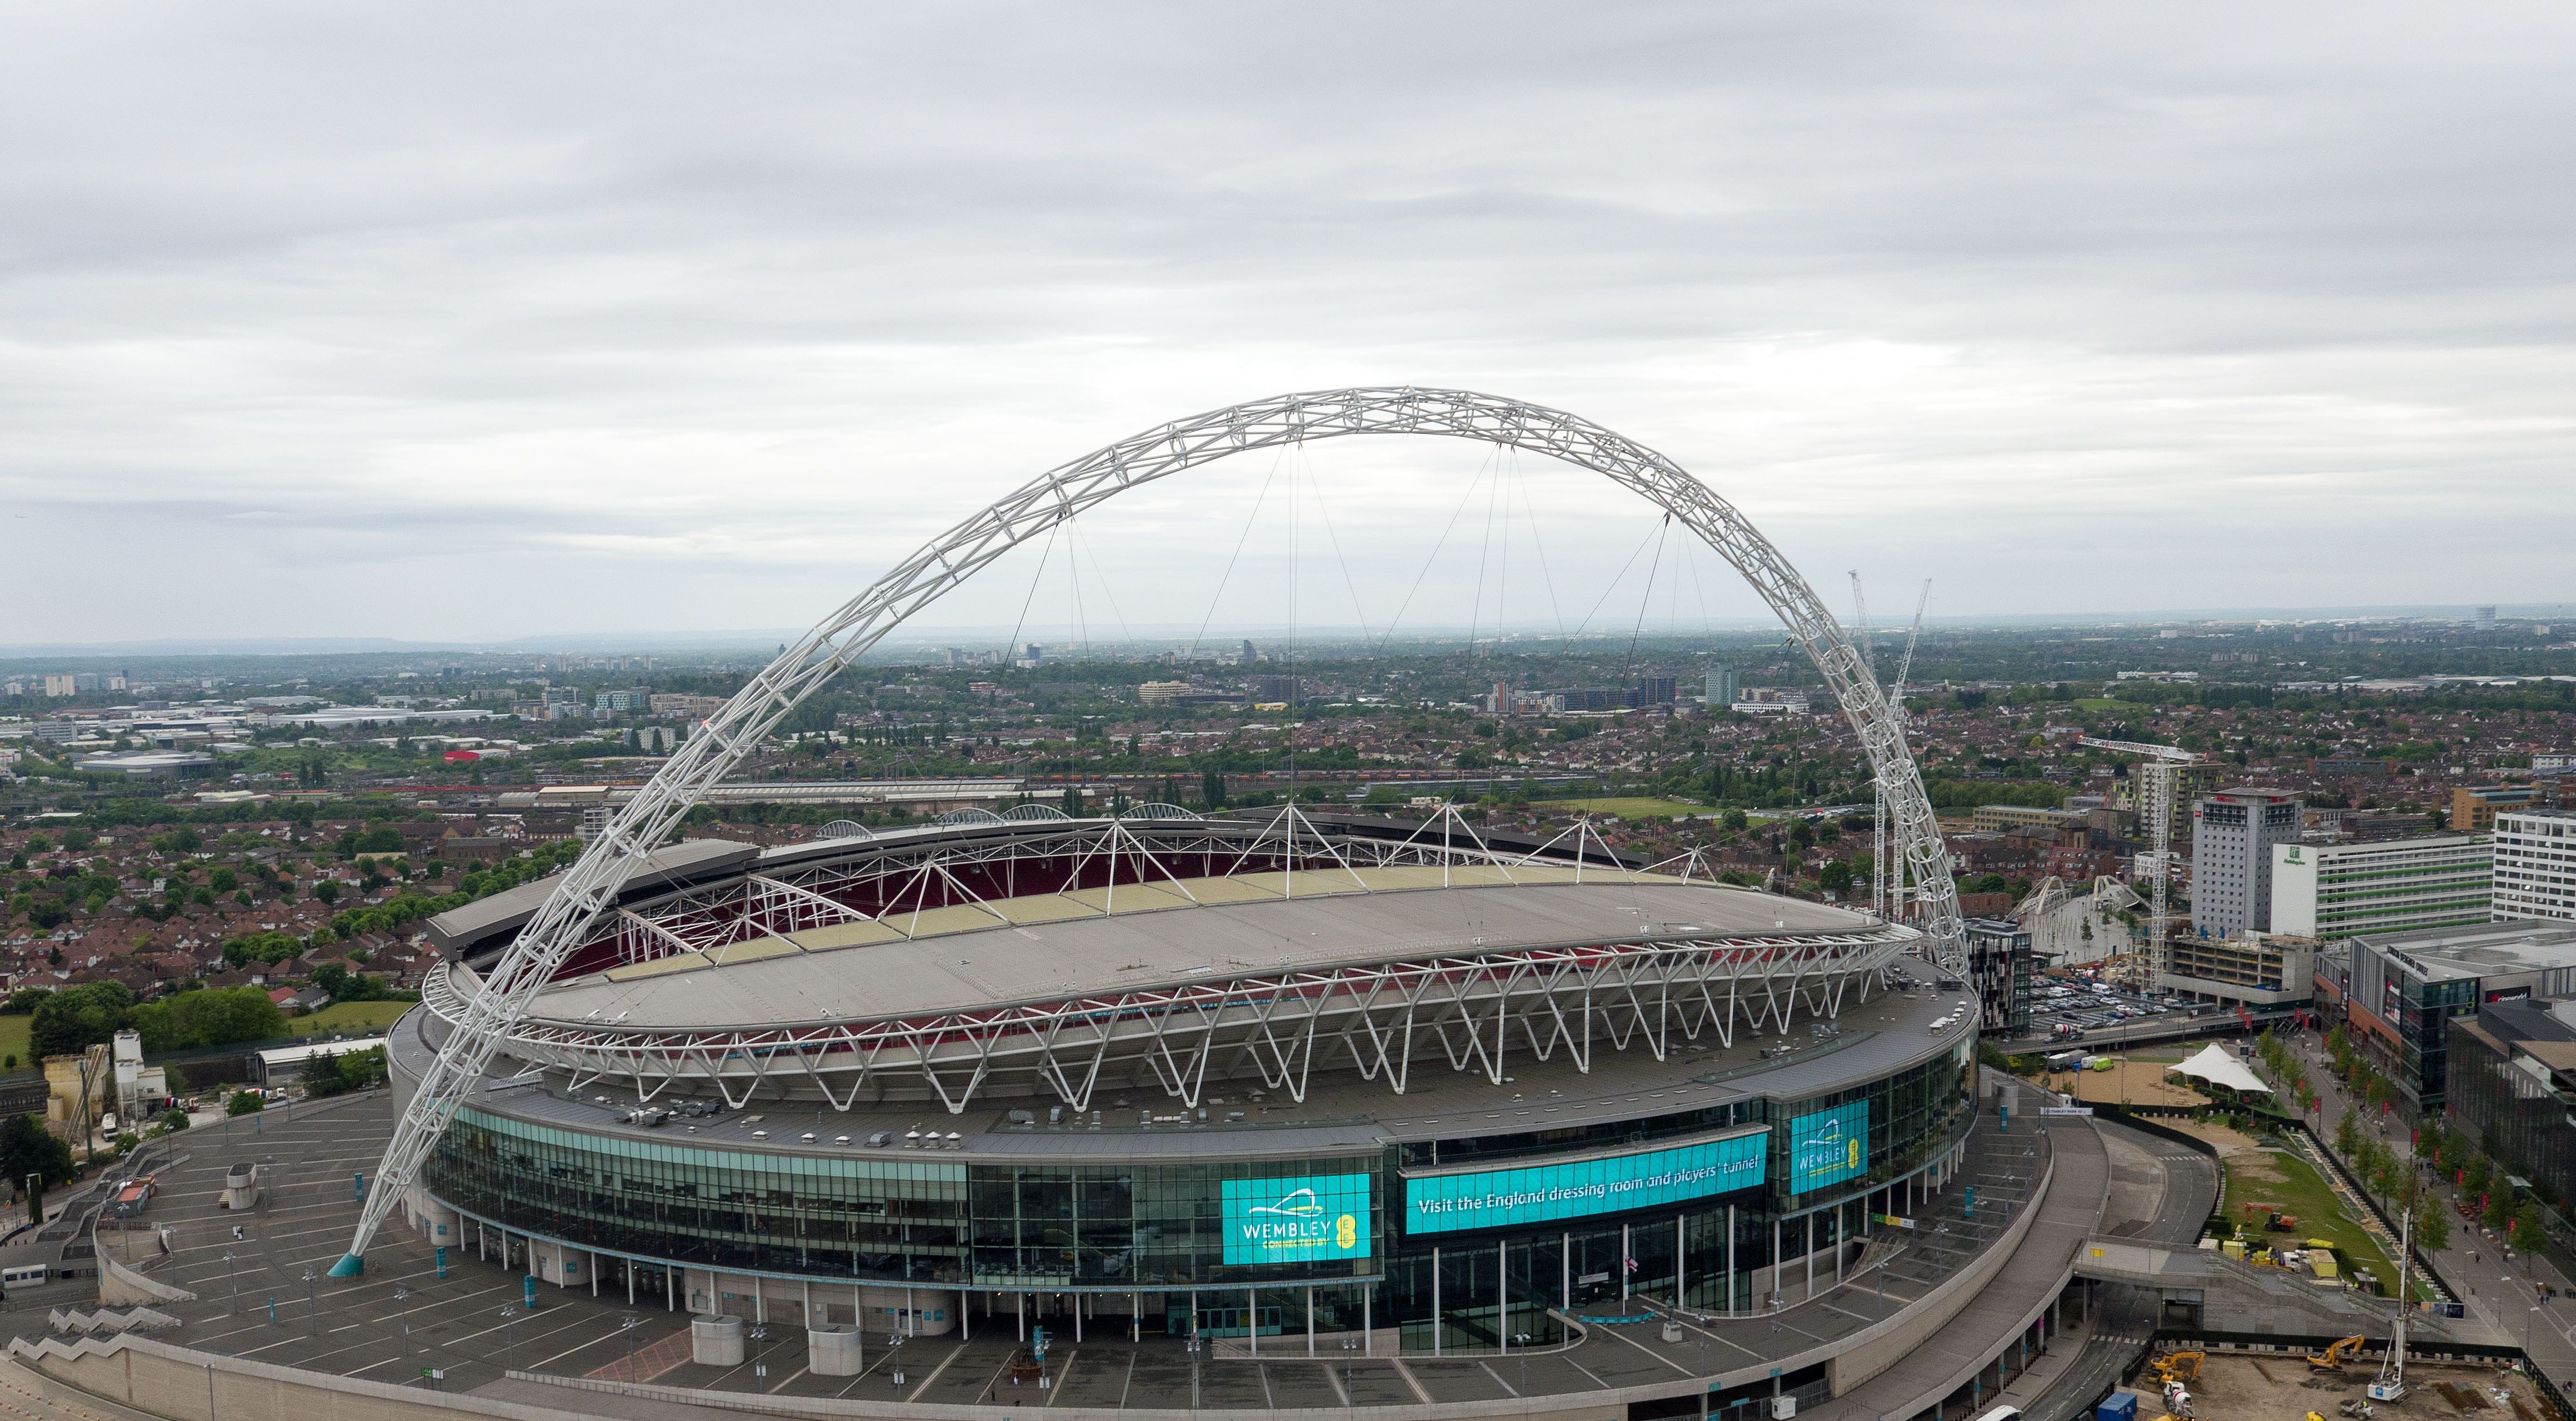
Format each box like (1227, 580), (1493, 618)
(1404, 1130), (1770, 1233)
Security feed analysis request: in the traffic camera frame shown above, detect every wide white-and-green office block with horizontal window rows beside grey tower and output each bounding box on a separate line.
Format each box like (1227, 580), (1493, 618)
(2272, 834), (2494, 940)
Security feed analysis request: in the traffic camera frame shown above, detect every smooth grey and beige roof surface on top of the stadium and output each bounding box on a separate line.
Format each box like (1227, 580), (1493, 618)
(533, 867), (1901, 1033)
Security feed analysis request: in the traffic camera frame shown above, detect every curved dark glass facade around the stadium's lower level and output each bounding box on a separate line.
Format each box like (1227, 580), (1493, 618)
(423, 1045), (1971, 1346)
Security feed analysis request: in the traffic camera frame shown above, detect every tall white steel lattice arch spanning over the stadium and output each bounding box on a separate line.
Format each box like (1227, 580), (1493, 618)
(332, 386), (1966, 1277)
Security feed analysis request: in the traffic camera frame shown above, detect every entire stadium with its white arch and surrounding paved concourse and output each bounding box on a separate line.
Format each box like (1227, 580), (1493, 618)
(10, 386), (2174, 1421)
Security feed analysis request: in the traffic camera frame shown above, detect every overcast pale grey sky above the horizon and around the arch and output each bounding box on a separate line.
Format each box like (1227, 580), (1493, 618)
(0, 2), (2576, 644)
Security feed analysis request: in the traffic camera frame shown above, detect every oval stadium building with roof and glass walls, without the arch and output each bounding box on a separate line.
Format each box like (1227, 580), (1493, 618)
(391, 811), (1976, 1351)
